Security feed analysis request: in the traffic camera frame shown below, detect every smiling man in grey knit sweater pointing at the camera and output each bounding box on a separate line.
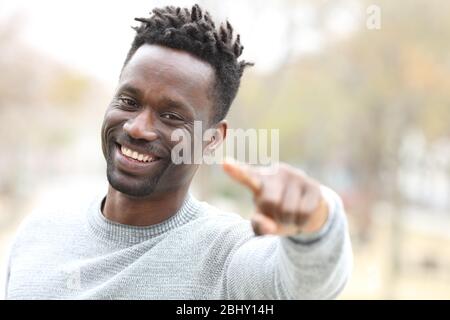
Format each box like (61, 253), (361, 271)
(6, 5), (352, 299)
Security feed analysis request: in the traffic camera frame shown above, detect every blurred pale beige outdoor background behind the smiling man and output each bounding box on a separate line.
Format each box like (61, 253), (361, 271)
(0, 0), (450, 299)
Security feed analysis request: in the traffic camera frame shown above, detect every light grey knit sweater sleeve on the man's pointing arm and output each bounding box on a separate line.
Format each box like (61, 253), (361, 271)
(225, 186), (353, 299)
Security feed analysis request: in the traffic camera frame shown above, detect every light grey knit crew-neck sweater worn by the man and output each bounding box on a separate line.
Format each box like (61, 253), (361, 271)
(6, 187), (352, 299)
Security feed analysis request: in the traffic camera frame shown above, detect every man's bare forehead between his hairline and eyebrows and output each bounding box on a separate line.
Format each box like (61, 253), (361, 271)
(119, 44), (214, 110)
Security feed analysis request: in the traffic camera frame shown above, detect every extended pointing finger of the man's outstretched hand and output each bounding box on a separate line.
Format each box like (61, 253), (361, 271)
(222, 158), (261, 194)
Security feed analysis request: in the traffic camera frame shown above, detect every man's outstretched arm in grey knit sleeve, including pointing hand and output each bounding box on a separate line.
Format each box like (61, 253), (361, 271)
(224, 163), (352, 299)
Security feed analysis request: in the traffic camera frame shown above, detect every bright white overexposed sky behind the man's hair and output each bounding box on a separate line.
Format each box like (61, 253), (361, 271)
(0, 0), (356, 83)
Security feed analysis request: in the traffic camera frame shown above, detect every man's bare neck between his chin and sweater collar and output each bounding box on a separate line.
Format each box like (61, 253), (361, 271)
(102, 185), (189, 226)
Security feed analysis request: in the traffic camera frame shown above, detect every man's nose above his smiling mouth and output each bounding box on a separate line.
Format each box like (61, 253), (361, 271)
(123, 108), (158, 141)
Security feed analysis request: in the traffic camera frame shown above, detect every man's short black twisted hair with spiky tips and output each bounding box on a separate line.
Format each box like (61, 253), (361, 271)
(122, 4), (253, 122)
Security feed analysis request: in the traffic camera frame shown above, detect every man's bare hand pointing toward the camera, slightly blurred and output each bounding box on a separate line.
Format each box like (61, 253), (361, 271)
(223, 159), (328, 236)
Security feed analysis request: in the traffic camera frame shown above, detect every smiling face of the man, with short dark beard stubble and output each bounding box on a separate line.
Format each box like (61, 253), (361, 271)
(102, 45), (214, 197)
